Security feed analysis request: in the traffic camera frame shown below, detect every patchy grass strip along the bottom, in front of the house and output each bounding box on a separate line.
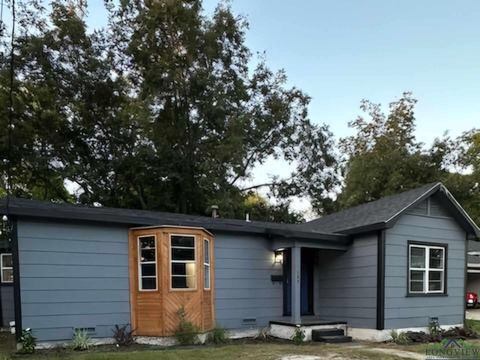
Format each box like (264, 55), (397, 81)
(0, 335), (416, 360)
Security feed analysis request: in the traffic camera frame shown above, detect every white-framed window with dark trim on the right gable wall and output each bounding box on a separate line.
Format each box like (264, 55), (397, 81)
(408, 243), (447, 294)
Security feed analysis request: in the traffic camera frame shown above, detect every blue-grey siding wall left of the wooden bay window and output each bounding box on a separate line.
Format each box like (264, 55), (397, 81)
(18, 219), (130, 341)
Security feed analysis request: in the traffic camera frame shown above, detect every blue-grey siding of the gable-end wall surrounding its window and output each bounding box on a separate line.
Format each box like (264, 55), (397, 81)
(385, 208), (466, 329)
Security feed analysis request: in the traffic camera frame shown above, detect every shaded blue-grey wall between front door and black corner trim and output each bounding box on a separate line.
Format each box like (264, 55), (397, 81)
(314, 234), (378, 328)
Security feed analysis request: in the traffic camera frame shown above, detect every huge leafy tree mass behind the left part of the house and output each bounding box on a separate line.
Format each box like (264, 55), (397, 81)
(0, 0), (337, 220)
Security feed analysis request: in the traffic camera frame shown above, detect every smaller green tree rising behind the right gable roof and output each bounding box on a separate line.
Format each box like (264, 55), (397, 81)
(338, 93), (449, 208)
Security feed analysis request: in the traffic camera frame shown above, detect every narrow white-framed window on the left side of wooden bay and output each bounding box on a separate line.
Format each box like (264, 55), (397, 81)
(137, 235), (158, 291)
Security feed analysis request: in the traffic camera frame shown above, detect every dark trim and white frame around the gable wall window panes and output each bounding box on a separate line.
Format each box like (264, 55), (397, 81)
(406, 240), (448, 297)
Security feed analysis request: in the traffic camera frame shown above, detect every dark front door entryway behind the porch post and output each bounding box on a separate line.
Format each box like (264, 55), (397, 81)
(283, 249), (316, 316)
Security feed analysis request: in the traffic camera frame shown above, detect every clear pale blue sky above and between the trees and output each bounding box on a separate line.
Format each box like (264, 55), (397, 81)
(11, 0), (480, 217)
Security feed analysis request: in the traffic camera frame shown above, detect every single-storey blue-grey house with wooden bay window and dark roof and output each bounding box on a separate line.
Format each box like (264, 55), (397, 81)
(0, 183), (480, 342)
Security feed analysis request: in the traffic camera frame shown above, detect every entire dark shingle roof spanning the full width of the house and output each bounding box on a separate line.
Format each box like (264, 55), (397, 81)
(0, 183), (480, 241)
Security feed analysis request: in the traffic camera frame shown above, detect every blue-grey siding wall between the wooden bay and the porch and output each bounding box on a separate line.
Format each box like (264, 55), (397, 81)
(215, 233), (283, 329)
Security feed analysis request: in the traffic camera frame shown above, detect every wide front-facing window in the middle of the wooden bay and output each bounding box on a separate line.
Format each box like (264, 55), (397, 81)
(170, 234), (197, 290)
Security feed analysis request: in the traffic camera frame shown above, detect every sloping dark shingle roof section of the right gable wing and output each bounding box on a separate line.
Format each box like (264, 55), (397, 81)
(302, 182), (456, 233)
